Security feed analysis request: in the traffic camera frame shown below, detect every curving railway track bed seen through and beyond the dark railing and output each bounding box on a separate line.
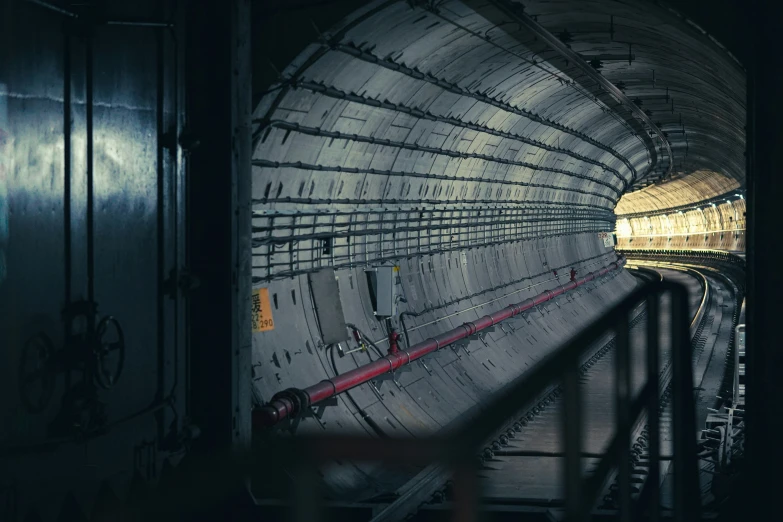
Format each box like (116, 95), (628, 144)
(392, 264), (736, 522)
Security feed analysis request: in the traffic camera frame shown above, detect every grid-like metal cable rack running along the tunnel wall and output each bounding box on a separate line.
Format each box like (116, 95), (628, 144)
(252, 204), (614, 282)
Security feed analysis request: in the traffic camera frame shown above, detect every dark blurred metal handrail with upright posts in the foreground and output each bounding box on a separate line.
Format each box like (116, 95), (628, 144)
(258, 280), (700, 522)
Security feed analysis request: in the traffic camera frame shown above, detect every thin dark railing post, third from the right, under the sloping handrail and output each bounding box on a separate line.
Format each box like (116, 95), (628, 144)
(614, 315), (631, 522)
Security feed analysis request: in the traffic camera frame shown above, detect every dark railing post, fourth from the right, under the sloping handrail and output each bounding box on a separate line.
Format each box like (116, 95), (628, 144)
(561, 359), (580, 522)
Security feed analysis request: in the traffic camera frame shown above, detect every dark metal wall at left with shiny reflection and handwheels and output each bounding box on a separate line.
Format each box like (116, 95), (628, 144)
(0, 0), (187, 520)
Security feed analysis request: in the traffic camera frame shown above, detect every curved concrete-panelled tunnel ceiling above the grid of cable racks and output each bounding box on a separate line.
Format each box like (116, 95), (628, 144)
(253, 0), (745, 240)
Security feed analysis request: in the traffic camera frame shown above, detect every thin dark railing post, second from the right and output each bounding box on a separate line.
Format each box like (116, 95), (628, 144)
(646, 293), (661, 522)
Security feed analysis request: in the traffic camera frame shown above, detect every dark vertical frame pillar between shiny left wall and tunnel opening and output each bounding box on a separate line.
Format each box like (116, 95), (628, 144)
(186, 0), (252, 452)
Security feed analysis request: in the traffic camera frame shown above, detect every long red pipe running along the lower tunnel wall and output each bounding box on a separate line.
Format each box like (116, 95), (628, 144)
(253, 257), (625, 428)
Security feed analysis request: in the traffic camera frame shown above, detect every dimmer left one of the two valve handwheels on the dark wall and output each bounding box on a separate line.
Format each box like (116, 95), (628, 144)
(19, 333), (55, 413)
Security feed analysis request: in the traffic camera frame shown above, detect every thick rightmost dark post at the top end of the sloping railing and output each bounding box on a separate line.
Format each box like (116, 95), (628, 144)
(671, 289), (701, 522)
